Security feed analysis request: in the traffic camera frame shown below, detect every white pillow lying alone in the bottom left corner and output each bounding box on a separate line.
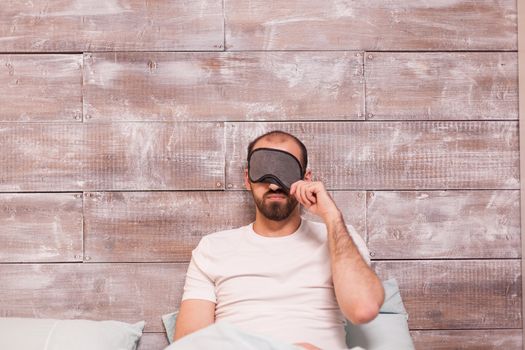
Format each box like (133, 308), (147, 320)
(0, 317), (145, 350)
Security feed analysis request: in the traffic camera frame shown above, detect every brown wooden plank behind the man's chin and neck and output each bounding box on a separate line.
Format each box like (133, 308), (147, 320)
(84, 191), (365, 262)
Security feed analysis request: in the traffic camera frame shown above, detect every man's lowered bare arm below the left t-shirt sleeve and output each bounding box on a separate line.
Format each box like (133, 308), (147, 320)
(173, 299), (215, 341)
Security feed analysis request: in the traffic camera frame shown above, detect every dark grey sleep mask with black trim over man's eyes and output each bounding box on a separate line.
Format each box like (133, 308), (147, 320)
(248, 148), (304, 193)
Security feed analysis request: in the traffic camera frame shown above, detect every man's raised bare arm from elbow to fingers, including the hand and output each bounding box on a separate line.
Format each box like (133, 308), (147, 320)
(290, 180), (385, 324)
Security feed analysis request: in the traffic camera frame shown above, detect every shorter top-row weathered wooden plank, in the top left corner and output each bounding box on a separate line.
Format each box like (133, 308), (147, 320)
(0, 0), (224, 52)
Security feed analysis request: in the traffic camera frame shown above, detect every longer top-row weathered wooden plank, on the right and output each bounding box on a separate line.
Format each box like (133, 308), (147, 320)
(225, 0), (517, 51)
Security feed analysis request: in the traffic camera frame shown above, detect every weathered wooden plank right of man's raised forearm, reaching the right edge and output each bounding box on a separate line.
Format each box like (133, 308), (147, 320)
(366, 190), (521, 259)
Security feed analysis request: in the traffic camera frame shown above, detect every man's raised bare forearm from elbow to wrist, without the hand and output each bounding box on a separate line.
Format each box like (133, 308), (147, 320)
(325, 214), (385, 324)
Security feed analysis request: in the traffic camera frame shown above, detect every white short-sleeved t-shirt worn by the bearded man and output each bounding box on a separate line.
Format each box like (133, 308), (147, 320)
(182, 218), (370, 350)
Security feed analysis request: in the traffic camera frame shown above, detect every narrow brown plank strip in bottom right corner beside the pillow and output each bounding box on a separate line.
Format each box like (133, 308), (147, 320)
(411, 329), (522, 350)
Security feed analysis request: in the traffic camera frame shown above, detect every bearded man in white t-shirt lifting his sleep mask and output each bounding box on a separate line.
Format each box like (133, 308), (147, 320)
(174, 131), (384, 349)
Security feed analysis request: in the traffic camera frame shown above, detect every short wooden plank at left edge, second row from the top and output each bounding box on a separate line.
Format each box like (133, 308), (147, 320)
(0, 54), (82, 122)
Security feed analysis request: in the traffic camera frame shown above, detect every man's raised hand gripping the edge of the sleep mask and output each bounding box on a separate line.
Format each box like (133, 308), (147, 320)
(290, 180), (341, 223)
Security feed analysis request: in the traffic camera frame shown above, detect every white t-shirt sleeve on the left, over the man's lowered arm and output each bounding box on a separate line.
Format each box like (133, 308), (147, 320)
(181, 237), (217, 303)
